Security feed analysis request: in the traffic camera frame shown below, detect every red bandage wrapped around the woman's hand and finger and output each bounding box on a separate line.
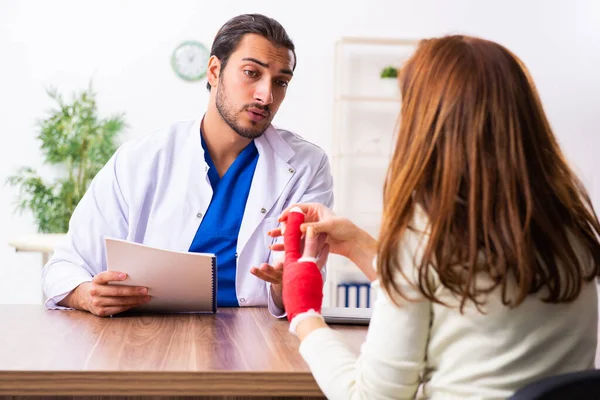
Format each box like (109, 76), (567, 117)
(283, 208), (323, 322)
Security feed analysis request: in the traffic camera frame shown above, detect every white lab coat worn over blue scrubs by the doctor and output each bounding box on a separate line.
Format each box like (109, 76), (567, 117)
(42, 119), (333, 316)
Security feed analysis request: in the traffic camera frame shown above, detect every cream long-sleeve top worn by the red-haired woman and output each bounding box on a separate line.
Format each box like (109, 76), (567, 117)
(300, 211), (598, 400)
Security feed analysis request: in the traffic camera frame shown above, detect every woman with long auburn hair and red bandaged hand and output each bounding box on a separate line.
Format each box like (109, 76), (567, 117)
(272, 36), (600, 399)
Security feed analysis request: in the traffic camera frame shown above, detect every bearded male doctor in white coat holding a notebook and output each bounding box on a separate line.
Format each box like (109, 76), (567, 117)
(42, 14), (333, 317)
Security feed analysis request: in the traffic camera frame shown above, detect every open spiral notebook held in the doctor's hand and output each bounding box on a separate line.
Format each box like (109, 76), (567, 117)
(105, 238), (217, 313)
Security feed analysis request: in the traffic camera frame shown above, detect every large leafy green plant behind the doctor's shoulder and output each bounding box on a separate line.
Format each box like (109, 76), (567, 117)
(7, 84), (126, 233)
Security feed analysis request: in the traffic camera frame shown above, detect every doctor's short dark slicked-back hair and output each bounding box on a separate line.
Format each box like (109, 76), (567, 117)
(206, 14), (296, 91)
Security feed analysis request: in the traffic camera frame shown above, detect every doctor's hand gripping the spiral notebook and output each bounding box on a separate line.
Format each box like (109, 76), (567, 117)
(60, 271), (150, 317)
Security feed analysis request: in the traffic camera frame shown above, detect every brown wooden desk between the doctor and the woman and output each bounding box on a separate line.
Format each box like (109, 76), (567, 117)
(0, 305), (366, 398)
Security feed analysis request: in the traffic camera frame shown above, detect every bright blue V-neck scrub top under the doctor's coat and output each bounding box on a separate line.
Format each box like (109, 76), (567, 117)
(189, 132), (258, 307)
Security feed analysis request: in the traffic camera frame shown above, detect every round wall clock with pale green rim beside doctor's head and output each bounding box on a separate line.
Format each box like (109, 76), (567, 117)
(171, 40), (210, 82)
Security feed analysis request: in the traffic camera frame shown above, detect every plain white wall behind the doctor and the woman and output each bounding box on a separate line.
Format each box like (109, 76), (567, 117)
(0, 0), (600, 304)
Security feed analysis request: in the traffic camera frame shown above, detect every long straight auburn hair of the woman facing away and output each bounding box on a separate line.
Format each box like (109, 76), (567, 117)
(377, 35), (600, 311)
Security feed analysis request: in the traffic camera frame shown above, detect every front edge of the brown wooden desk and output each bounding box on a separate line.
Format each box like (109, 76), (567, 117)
(0, 371), (323, 396)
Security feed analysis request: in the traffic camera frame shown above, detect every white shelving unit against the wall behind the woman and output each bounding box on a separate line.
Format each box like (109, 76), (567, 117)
(324, 37), (418, 307)
